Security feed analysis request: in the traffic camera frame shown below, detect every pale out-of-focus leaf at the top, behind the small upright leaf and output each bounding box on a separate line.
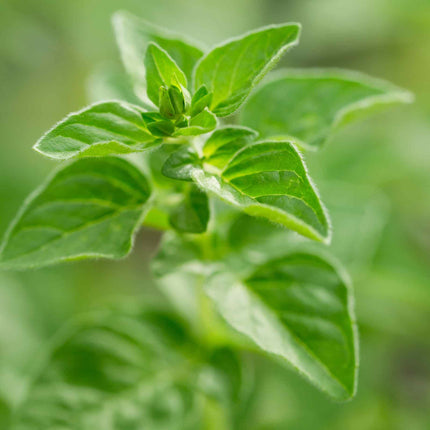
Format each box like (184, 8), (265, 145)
(113, 11), (203, 98)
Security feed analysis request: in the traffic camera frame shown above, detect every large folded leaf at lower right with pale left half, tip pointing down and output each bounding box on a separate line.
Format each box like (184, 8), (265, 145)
(205, 252), (358, 400)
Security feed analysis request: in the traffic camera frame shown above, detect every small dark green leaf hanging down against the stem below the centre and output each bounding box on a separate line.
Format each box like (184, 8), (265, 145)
(170, 184), (210, 233)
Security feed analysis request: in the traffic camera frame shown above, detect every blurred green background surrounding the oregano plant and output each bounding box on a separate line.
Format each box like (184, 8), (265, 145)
(0, 0), (430, 430)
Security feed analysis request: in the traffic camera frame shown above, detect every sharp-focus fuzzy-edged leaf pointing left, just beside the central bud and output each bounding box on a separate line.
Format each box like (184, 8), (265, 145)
(34, 101), (158, 159)
